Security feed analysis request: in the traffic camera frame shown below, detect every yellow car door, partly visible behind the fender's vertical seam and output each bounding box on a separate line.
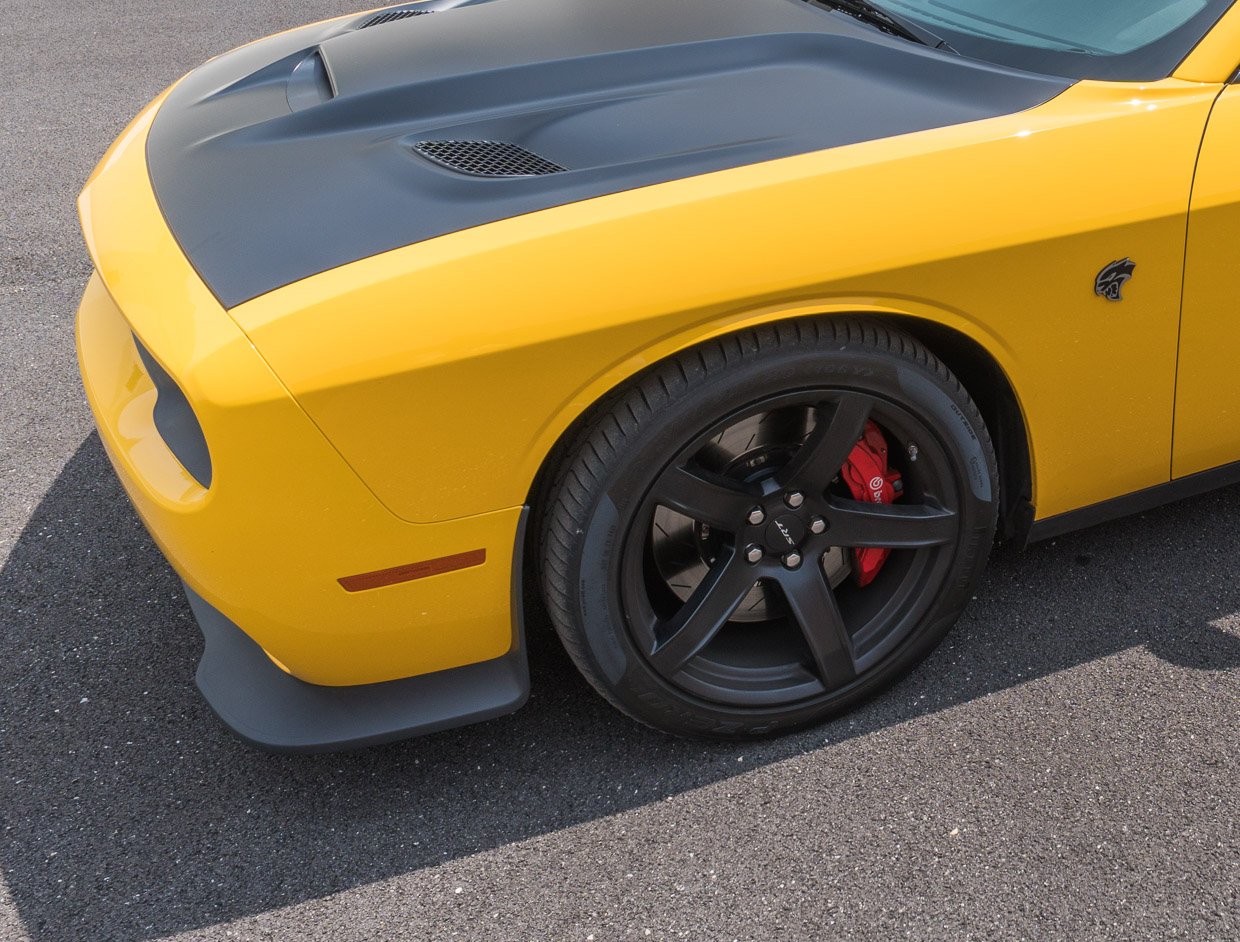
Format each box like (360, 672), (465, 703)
(1172, 84), (1240, 477)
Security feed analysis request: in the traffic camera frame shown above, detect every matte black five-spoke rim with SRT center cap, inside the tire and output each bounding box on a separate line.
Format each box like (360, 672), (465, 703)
(621, 389), (960, 705)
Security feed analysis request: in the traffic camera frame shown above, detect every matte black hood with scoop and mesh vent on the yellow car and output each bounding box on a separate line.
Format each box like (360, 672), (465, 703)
(148, 0), (1065, 306)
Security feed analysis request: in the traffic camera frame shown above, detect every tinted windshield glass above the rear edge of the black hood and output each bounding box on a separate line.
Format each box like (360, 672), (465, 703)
(878, 0), (1234, 82)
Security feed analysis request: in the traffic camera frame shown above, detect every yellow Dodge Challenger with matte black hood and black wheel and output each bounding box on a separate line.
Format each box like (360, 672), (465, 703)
(77, 0), (1240, 750)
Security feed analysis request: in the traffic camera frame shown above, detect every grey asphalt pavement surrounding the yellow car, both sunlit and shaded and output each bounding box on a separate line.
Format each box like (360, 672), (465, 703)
(0, 0), (1240, 942)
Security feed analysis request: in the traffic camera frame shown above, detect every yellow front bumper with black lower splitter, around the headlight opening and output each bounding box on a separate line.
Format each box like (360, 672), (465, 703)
(78, 89), (526, 749)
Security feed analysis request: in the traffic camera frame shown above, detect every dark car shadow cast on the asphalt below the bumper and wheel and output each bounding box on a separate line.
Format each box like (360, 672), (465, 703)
(7, 436), (1240, 941)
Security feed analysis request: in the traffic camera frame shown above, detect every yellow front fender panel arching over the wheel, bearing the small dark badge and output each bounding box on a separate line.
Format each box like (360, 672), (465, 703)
(231, 79), (1218, 521)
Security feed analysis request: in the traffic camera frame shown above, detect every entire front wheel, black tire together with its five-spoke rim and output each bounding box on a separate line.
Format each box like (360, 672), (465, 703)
(541, 317), (998, 739)
